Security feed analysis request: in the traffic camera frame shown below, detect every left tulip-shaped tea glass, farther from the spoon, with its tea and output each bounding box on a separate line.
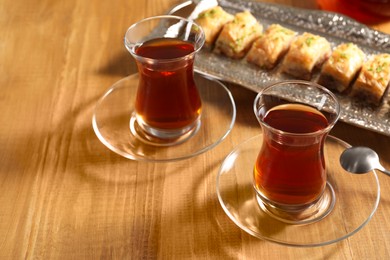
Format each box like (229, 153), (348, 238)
(124, 15), (205, 145)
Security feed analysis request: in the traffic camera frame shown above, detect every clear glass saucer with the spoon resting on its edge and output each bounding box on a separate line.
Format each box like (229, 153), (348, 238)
(217, 134), (380, 247)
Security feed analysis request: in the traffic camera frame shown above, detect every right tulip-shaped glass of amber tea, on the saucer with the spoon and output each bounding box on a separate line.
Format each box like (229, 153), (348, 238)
(253, 80), (340, 223)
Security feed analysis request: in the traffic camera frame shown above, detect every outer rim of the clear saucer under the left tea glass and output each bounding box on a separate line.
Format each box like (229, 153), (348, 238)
(92, 71), (237, 163)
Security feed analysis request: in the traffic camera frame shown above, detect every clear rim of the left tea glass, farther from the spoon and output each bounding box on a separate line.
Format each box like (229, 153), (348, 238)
(124, 15), (206, 63)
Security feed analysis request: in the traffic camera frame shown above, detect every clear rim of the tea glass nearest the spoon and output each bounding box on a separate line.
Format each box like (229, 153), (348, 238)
(253, 80), (341, 137)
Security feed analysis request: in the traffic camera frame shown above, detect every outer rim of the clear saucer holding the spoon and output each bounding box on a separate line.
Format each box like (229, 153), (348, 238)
(216, 133), (380, 248)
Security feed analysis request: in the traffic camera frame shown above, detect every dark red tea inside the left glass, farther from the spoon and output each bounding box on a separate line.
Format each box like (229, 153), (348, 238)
(135, 38), (201, 129)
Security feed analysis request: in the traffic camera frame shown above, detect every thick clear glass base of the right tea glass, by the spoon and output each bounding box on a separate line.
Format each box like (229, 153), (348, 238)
(256, 182), (336, 224)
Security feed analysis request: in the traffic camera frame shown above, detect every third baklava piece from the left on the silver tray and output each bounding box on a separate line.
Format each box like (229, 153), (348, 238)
(246, 24), (296, 69)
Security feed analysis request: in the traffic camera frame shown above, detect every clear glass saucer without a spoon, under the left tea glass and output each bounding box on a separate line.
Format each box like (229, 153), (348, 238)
(92, 74), (236, 162)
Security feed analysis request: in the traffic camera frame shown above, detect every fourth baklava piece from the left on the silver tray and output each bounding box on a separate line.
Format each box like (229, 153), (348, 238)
(282, 32), (331, 80)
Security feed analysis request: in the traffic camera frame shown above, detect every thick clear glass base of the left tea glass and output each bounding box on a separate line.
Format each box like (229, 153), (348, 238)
(130, 112), (201, 146)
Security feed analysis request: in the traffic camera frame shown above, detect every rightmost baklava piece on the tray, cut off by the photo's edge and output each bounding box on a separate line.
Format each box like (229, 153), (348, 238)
(350, 53), (390, 105)
